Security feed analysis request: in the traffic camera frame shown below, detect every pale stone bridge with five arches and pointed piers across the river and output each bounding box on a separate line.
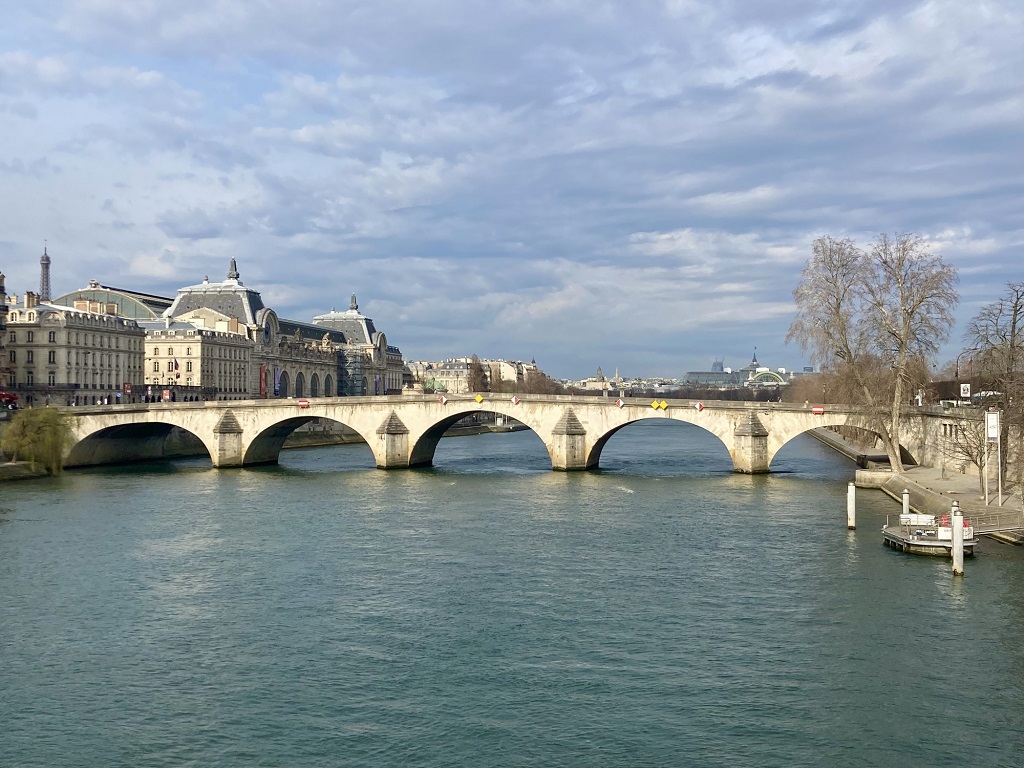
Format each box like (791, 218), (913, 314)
(59, 394), (926, 474)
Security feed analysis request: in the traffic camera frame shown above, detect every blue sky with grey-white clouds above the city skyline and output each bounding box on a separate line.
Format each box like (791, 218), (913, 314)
(0, 0), (1024, 378)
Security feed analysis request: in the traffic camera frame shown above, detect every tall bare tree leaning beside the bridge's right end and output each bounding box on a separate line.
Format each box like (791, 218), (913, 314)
(786, 233), (959, 471)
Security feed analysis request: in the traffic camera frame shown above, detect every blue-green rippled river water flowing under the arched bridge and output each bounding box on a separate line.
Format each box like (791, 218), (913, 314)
(0, 422), (1024, 767)
